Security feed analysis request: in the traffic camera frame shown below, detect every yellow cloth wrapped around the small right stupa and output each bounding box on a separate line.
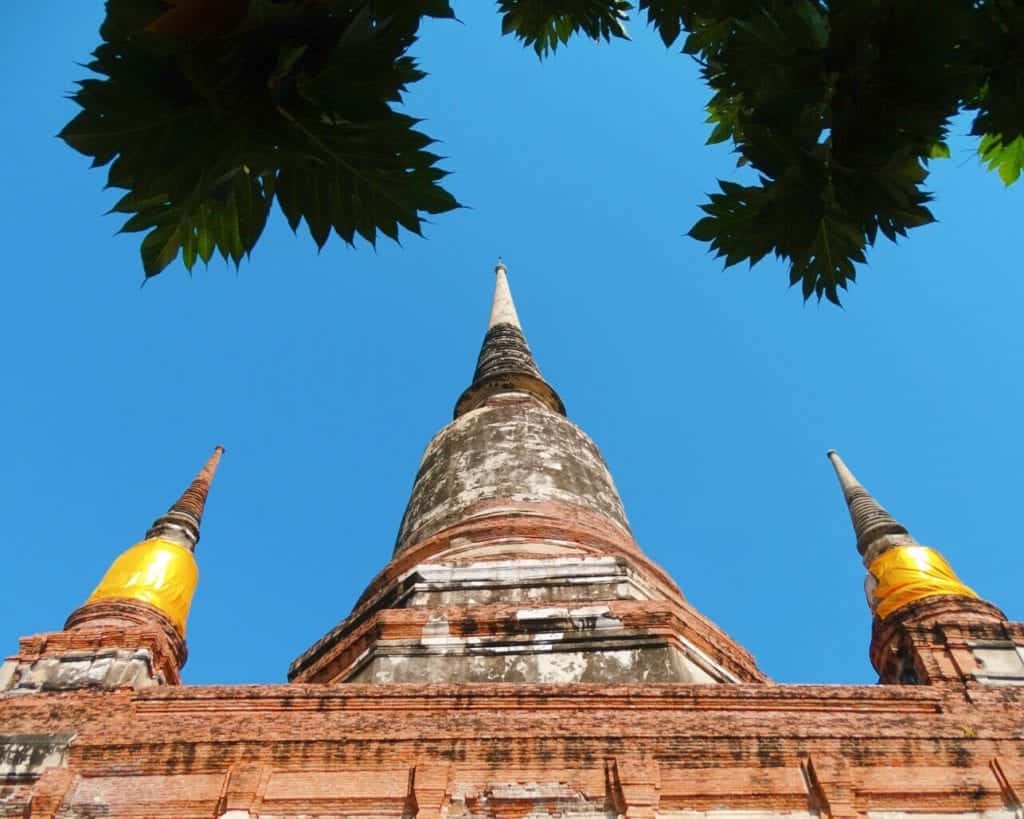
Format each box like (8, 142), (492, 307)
(867, 546), (978, 617)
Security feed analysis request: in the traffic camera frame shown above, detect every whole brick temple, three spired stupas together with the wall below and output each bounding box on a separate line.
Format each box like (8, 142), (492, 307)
(0, 265), (1024, 819)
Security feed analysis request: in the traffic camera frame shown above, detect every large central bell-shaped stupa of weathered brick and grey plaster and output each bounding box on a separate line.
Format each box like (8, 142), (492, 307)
(289, 264), (765, 684)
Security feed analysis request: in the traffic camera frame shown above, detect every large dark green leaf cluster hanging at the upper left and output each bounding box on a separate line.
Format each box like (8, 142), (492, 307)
(60, 0), (458, 276)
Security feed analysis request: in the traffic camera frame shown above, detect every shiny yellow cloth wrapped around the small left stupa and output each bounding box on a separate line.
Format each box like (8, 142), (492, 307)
(86, 537), (199, 637)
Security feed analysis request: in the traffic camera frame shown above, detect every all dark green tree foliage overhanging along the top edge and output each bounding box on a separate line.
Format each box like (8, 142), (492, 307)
(61, 0), (1024, 303)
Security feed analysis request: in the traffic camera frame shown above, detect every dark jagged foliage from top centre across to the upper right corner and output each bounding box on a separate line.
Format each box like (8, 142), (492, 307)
(503, 0), (1024, 304)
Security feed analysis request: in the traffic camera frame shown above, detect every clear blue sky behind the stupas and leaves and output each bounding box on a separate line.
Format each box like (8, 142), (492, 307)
(0, 6), (1024, 683)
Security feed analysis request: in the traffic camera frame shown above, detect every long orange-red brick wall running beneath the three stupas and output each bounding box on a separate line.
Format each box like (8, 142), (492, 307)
(0, 684), (1024, 819)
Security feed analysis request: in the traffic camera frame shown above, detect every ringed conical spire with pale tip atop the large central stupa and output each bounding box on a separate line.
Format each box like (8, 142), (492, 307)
(455, 260), (565, 418)
